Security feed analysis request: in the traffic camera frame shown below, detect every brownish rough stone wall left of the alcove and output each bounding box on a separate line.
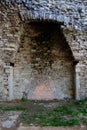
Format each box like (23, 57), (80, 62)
(0, 3), (20, 100)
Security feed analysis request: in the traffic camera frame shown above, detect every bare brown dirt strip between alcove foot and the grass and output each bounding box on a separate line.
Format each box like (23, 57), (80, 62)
(0, 100), (68, 115)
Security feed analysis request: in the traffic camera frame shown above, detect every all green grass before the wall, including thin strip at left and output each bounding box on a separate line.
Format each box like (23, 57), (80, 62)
(0, 100), (87, 126)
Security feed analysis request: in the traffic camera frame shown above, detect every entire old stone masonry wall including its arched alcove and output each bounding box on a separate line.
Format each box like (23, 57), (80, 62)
(0, 0), (87, 101)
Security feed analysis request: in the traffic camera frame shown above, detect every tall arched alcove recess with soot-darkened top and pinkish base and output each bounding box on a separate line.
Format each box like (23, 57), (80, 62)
(13, 22), (75, 100)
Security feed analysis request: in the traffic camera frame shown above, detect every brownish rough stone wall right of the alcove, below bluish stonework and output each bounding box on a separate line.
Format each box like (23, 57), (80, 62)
(65, 31), (87, 98)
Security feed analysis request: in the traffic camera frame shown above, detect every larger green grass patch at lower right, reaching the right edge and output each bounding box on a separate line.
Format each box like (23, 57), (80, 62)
(22, 101), (87, 126)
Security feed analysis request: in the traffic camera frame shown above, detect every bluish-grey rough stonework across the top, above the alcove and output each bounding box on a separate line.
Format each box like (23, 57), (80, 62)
(6, 0), (87, 30)
